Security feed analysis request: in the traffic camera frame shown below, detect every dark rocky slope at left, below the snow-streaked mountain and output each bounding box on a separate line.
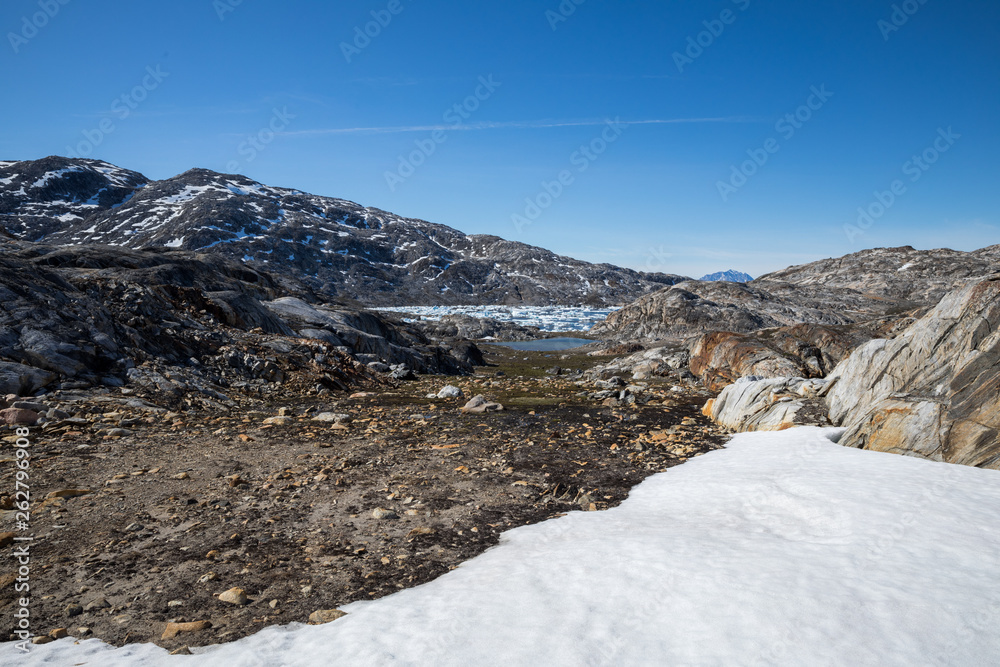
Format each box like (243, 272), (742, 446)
(0, 240), (482, 407)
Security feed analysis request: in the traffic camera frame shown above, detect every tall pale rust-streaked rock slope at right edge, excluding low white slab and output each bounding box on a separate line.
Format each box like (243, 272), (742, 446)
(828, 274), (1000, 468)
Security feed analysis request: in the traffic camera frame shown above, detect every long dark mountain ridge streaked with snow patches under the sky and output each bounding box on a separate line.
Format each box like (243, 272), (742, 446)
(0, 157), (683, 306)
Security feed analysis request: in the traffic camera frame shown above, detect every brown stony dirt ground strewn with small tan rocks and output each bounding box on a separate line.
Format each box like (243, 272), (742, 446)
(0, 346), (726, 649)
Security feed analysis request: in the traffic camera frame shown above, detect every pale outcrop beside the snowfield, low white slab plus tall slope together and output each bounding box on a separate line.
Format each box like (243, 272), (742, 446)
(704, 273), (1000, 469)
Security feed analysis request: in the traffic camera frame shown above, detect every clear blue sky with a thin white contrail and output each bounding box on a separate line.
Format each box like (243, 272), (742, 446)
(0, 0), (1000, 277)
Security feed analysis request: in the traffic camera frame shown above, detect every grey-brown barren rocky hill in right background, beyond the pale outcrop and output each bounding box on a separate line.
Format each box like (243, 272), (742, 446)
(594, 245), (1000, 340)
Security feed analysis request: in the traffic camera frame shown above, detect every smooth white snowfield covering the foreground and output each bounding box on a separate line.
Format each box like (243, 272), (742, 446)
(9, 428), (1000, 667)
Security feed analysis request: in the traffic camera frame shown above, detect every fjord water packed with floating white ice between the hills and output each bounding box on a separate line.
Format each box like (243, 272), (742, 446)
(373, 306), (618, 332)
